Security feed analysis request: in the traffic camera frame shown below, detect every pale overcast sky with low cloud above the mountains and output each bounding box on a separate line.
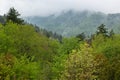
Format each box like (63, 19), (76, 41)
(0, 0), (120, 16)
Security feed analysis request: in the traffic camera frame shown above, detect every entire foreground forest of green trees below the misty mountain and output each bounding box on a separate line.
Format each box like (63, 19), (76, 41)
(0, 8), (120, 80)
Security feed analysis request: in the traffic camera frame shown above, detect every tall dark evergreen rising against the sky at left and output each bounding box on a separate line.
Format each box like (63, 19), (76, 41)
(5, 8), (24, 24)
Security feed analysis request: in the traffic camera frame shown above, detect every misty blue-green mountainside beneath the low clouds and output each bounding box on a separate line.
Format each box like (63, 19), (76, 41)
(25, 11), (120, 36)
